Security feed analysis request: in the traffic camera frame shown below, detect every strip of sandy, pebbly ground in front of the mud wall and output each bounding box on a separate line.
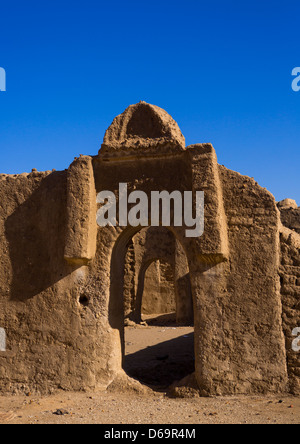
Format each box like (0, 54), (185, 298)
(0, 392), (300, 424)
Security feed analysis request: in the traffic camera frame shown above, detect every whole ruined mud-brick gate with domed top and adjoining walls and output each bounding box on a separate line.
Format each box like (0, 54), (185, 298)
(0, 102), (300, 396)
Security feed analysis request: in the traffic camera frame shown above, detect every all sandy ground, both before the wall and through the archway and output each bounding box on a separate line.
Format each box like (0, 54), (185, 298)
(0, 318), (300, 424)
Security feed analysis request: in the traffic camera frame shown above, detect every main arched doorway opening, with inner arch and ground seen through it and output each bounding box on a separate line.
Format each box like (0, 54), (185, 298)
(114, 227), (195, 390)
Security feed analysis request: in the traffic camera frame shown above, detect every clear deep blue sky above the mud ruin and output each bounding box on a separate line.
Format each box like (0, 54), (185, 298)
(0, 0), (300, 205)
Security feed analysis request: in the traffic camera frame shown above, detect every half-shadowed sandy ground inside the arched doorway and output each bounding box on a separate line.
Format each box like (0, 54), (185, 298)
(124, 316), (195, 390)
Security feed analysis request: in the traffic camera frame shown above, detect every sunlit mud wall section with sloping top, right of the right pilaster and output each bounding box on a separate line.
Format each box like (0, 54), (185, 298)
(213, 166), (287, 393)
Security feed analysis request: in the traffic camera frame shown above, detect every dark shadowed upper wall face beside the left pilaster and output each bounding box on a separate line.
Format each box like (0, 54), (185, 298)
(0, 173), (67, 302)
